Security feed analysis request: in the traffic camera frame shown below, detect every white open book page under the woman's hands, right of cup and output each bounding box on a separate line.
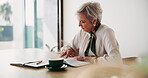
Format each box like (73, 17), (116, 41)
(64, 57), (90, 67)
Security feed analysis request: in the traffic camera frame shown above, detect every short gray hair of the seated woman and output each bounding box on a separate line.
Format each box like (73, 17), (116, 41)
(77, 2), (103, 22)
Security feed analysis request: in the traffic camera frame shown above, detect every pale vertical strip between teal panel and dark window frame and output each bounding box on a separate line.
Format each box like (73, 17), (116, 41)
(43, 0), (57, 49)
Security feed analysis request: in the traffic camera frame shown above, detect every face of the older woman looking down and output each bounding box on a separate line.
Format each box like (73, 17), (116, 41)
(78, 13), (94, 32)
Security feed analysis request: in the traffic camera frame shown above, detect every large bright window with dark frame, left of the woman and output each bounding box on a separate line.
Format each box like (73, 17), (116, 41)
(0, 0), (62, 50)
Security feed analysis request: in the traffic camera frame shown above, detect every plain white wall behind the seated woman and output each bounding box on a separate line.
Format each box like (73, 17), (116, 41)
(64, 0), (148, 57)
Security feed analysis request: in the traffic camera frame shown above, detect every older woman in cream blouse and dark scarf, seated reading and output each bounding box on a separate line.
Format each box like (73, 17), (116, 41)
(61, 2), (122, 63)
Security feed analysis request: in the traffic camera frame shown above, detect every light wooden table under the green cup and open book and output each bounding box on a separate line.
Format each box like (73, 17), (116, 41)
(0, 49), (146, 78)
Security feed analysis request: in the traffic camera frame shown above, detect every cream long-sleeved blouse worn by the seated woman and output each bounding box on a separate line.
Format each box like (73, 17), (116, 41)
(66, 25), (122, 62)
